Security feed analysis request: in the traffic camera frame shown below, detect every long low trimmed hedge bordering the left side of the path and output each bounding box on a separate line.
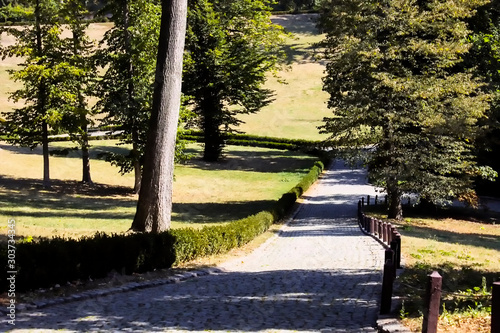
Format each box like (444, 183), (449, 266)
(0, 162), (324, 291)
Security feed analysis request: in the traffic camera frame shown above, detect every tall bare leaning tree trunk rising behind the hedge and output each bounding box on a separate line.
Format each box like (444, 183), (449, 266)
(131, 0), (187, 232)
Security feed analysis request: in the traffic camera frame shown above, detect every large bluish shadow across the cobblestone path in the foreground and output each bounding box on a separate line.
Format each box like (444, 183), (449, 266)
(9, 270), (380, 332)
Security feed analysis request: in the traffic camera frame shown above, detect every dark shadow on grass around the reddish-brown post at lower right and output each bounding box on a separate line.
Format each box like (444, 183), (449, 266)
(395, 262), (500, 318)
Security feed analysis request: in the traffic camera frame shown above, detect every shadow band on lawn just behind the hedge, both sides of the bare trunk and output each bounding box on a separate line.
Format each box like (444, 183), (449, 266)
(0, 176), (275, 232)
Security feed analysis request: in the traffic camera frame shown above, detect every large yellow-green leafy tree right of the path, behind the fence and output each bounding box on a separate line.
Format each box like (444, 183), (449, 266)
(319, 0), (494, 218)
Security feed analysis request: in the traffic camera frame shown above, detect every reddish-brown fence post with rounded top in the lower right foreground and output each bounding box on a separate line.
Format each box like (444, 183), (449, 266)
(422, 271), (443, 333)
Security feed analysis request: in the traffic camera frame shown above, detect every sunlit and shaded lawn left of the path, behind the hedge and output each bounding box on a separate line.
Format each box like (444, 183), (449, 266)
(0, 141), (315, 237)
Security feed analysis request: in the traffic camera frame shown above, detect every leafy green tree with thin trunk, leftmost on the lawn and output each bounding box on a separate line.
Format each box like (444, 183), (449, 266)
(2, 0), (66, 187)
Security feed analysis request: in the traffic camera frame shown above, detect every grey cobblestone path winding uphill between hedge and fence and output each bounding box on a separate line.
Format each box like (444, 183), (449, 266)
(0, 162), (384, 333)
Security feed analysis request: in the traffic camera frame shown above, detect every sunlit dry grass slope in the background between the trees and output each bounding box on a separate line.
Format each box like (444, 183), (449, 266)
(240, 14), (331, 140)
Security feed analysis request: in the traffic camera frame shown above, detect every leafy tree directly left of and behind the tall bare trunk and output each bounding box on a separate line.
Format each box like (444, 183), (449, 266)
(97, 0), (161, 193)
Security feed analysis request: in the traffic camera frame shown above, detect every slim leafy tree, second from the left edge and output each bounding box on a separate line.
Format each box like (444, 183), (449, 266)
(58, 0), (97, 184)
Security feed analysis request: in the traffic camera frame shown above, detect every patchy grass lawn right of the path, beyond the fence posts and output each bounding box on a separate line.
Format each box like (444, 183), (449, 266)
(368, 209), (500, 333)
